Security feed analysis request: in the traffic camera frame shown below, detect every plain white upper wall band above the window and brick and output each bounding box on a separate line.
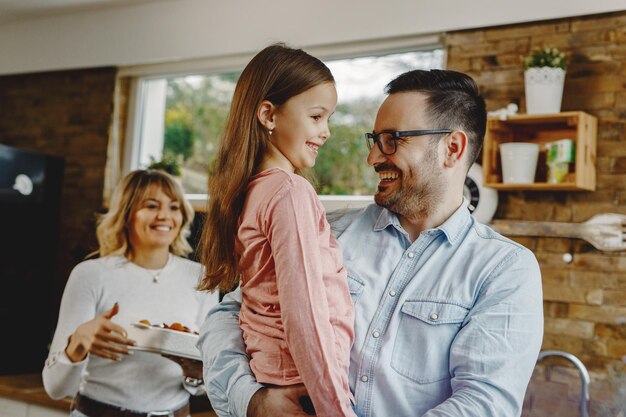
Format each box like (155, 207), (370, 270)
(0, 0), (626, 75)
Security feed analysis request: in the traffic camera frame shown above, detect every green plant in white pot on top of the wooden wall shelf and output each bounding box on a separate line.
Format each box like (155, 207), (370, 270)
(522, 48), (568, 114)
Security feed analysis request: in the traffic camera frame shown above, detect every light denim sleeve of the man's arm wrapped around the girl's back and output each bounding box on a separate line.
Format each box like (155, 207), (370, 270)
(197, 289), (262, 417)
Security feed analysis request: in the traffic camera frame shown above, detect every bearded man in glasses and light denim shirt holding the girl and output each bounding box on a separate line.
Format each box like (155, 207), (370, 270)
(198, 70), (543, 417)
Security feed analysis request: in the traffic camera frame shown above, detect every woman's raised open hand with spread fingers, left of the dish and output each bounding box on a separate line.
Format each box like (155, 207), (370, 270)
(65, 303), (135, 362)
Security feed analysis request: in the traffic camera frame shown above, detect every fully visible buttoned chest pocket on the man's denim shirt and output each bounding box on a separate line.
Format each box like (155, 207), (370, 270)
(391, 300), (469, 384)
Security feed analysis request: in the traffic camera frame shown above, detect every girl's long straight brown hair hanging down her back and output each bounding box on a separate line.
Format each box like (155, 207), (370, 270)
(198, 43), (334, 291)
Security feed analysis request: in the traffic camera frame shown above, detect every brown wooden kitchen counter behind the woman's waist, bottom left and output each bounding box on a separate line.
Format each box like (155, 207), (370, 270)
(0, 374), (217, 417)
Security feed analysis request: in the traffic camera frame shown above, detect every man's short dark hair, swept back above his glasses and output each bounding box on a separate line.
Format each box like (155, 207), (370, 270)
(385, 69), (487, 169)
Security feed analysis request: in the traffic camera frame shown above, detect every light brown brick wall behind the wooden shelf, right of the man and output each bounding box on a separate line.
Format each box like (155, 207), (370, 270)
(446, 12), (626, 417)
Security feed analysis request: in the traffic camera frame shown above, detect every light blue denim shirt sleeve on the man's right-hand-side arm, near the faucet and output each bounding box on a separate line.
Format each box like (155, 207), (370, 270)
(422, 248), (543, 417)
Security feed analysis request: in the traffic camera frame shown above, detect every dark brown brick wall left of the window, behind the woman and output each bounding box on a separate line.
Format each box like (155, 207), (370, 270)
(0, 68), (116, 316)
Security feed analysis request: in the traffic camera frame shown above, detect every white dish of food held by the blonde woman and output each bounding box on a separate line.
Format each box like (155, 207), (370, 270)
(126, 323), (202, 360)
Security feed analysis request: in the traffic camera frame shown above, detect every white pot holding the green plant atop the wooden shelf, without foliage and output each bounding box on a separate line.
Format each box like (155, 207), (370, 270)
(524, 67), (565, 114)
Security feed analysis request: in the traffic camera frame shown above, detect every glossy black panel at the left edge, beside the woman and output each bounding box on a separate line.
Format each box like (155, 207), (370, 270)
(0, 145), (64, 374)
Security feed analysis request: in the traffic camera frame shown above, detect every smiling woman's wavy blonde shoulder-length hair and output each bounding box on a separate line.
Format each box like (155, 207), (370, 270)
(96, 169), (194, 257)
